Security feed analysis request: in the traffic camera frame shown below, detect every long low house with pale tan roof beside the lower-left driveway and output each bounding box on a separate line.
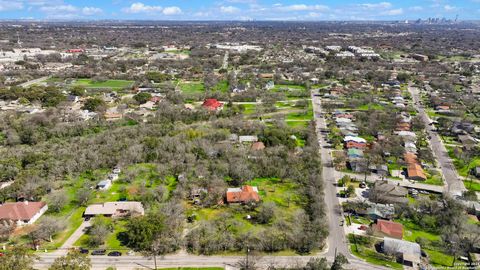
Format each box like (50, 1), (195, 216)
(83, 202), (145, 217)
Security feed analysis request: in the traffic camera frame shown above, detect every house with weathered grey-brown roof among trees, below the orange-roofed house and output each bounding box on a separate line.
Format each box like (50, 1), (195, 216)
(369, 181), (408, 204)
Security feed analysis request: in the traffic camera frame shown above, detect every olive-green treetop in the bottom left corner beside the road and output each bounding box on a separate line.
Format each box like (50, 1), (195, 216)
(0, 246), (37, 270)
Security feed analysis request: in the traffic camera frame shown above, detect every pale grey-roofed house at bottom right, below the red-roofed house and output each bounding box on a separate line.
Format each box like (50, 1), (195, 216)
(383, 237), (422, 267)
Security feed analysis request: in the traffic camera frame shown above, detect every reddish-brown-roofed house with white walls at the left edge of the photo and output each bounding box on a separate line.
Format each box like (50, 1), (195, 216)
(0, 201), (48, 226)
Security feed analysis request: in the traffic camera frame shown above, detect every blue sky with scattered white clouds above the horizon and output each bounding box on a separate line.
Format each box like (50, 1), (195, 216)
(0, 0), (480, 21)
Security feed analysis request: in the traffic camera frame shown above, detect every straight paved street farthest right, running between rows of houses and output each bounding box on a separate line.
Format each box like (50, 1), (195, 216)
(408, 85), (466, 196)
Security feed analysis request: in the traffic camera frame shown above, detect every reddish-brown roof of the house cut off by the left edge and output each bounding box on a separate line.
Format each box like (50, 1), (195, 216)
(0, 202), (46, 220)
